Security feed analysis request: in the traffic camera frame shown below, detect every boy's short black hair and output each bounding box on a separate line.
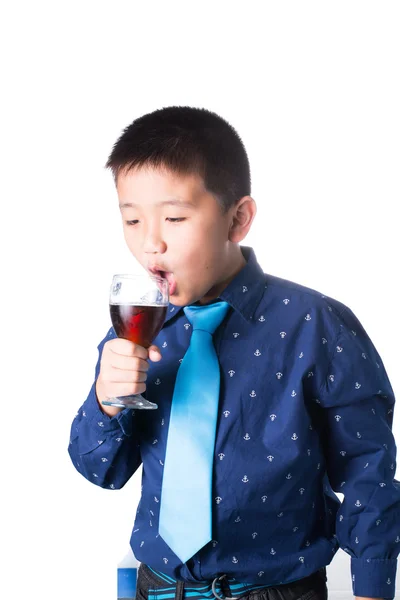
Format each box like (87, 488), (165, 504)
(105, 106), (251, 212)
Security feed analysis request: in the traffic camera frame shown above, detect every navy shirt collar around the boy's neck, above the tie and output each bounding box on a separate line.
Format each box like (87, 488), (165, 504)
(165, 246), (266, 323)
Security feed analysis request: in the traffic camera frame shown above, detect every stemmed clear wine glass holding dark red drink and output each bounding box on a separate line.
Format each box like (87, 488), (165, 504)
(102, 274), (169, 409)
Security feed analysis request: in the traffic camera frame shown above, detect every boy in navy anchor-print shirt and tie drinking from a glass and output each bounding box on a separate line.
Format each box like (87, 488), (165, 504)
(69, 107), (400, 600)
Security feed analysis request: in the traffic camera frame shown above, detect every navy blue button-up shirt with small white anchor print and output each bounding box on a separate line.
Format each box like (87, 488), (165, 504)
(69, 247), (400, 598)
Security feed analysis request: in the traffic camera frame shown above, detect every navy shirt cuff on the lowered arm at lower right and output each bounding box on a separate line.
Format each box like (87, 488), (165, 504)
(351, 557), (397, 600)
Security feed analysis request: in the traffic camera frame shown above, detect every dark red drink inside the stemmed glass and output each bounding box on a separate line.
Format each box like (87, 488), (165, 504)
(110, 304), (167, 348)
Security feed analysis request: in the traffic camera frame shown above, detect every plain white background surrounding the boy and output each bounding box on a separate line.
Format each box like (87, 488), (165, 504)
(0, 0), (400, 600)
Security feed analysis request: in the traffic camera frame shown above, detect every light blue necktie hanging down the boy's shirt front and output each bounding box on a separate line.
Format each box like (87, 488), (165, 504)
(159, 302), (229, 563)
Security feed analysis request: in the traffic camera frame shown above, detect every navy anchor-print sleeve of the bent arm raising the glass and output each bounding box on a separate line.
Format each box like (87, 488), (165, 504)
(68, 328), (142, 489)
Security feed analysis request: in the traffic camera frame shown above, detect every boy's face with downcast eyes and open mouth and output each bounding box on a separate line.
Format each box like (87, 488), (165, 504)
(117, 168), (245, 306)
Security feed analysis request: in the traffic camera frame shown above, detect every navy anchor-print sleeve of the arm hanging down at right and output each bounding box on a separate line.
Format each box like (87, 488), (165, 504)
(316, 305), (400, 599)
